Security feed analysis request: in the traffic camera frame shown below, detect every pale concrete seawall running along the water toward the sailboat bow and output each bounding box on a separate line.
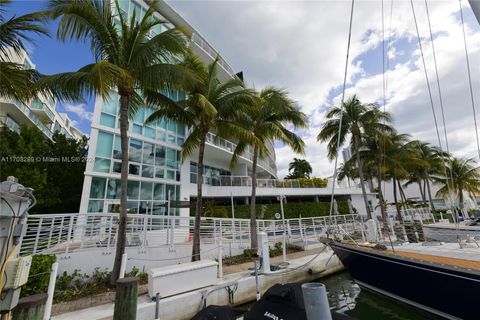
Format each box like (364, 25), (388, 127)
(52, 249), (343, 320)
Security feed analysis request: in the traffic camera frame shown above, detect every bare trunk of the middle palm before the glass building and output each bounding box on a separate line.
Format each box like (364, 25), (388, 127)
(192, 134), (206, 262)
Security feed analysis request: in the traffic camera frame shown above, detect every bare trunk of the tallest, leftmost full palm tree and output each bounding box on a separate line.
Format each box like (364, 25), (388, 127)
(110, 95), (129, 285)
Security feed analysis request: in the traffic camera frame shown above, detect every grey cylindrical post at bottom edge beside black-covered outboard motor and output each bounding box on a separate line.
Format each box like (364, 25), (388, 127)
(302, 282), (332, 320)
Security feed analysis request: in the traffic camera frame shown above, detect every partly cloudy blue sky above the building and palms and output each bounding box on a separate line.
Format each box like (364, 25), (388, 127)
(7, 0), (480, 177)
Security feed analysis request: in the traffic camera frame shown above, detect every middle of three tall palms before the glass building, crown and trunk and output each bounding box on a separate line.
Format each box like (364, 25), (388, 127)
(147, 56), (254, 261)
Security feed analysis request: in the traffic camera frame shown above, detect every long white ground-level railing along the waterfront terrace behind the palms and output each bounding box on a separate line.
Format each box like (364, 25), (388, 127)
(21, 213), (362, 254)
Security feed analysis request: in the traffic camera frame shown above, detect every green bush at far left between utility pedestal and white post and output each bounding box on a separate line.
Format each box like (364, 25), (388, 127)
(21, 254), (57, 297)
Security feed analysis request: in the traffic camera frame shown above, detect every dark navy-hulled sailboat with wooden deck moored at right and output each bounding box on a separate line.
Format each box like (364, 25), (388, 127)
(327, 0), (480, 320)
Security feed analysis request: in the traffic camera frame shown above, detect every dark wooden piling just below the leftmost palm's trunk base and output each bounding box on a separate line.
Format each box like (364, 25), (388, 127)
(113, 277), (139, 320)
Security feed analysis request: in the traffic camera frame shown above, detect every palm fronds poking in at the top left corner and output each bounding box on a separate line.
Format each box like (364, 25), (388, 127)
(0, 0), (48, 102)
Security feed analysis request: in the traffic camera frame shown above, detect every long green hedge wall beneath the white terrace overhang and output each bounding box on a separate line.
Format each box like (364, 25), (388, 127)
(190, 201), (350, 219)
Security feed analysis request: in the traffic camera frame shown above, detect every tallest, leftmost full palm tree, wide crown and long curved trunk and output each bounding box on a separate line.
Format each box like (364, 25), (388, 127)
(40, 0), (194, 284)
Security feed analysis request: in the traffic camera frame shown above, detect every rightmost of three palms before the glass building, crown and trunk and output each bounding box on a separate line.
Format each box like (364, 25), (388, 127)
(231, 87), (308, 251)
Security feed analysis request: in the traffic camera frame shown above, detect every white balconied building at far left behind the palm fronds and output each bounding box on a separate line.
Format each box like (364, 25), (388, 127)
(0, 50), (84, 139)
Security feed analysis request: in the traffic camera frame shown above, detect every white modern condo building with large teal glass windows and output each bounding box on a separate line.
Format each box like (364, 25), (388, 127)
(80, 0), (374, 215)
